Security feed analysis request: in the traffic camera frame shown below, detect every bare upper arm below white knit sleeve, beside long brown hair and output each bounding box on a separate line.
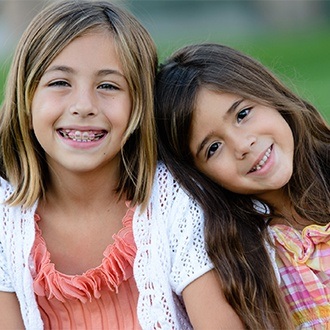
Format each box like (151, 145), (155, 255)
(182, 270), (244, 330)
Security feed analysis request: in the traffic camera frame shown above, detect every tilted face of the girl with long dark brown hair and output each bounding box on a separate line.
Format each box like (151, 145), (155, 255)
(190, 88), (294, 201)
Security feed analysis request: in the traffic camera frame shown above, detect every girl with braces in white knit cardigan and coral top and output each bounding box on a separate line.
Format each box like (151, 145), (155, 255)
(0, 1), (241, 329)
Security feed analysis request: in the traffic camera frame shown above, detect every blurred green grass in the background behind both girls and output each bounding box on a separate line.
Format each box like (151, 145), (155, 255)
(0, 27), (330, 123)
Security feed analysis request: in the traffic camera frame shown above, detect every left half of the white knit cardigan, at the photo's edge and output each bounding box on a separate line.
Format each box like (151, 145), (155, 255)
(0, 179), (43, 330)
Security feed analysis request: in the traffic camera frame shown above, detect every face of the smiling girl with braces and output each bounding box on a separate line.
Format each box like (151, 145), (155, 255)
(32, 32), (132, 177)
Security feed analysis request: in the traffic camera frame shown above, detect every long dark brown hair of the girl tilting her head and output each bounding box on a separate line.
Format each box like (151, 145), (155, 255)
(155, 44), (330, 329)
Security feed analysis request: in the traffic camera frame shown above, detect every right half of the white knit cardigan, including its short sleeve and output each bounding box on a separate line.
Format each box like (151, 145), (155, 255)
(133, 164), (213, 329)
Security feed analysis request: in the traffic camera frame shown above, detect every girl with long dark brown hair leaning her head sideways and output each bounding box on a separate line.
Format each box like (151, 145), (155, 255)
(156, 44), (330, 329)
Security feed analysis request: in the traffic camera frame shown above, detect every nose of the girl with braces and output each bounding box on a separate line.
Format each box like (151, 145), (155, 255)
(70, 88), (97, 117)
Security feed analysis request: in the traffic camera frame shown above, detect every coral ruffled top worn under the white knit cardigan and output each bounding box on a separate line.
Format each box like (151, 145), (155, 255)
(32, 209), (141, 330)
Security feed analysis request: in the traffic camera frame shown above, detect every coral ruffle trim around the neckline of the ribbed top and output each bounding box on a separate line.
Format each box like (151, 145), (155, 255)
(32, 209), (136, 303)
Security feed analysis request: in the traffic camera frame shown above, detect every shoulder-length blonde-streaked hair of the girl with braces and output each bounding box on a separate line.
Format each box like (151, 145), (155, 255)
(0, 1), (157, 207)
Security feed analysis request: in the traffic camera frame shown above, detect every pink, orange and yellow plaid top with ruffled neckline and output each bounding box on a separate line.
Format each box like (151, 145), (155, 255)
(271, 224), (330, 329)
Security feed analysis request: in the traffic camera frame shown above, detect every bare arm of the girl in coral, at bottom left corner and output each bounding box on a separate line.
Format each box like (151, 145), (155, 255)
(0, 291), (24, 330)
